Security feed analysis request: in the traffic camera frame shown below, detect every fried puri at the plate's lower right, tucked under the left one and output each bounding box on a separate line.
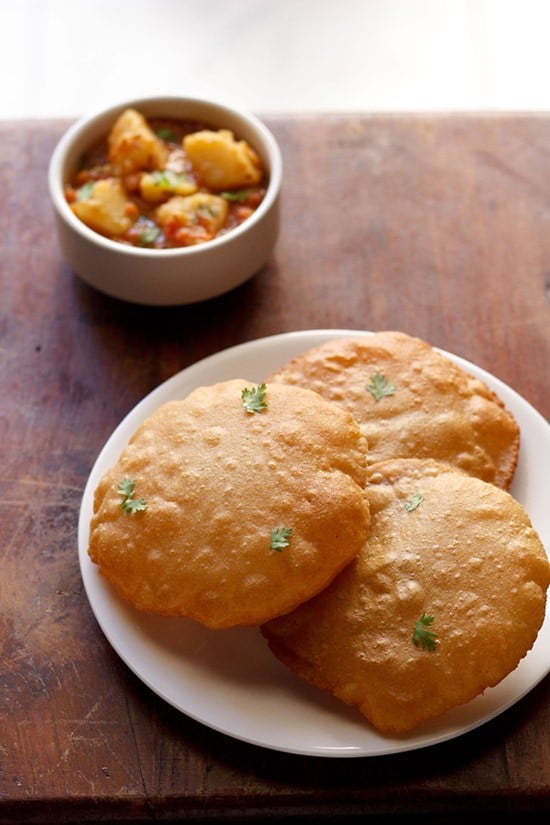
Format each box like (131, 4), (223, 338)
(263, 460), (550, 734)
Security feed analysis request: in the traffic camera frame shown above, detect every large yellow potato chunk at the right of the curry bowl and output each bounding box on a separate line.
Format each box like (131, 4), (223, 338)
(183, 129), (262, 190)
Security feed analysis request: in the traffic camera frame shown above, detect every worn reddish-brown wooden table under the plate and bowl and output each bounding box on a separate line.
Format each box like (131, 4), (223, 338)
(0, 115), (550, 823)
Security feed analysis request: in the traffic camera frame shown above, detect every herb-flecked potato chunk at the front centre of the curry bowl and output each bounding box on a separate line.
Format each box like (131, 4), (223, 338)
(155, 192), (228, 245)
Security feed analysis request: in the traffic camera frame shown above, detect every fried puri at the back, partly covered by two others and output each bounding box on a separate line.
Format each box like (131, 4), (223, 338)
(270, 331), (520, 490)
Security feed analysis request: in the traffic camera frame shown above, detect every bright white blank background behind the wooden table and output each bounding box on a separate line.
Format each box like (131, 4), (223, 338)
(0, 0), (550, 118)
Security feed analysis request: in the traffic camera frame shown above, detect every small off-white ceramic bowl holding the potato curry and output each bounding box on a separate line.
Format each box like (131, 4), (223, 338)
(48, 97), (282, 306)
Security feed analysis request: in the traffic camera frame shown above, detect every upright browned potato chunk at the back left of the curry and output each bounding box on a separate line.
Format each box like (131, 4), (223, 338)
(107, 109), (168, 175)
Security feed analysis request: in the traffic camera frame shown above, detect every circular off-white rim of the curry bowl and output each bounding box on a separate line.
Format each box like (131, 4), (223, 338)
(47, 95), (283, 254)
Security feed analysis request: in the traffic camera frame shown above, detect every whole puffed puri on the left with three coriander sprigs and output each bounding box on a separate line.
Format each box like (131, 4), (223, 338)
(89, 379), (369, 628)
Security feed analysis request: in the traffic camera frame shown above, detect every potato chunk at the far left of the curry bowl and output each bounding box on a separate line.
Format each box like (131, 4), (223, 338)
(71, 178), (133, 236)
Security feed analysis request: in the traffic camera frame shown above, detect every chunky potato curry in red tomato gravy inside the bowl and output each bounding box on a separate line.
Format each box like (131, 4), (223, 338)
(65, 109), (267, 249)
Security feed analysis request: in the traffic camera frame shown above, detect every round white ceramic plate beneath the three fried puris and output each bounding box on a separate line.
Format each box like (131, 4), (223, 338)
(78, 330), (550, 757)
